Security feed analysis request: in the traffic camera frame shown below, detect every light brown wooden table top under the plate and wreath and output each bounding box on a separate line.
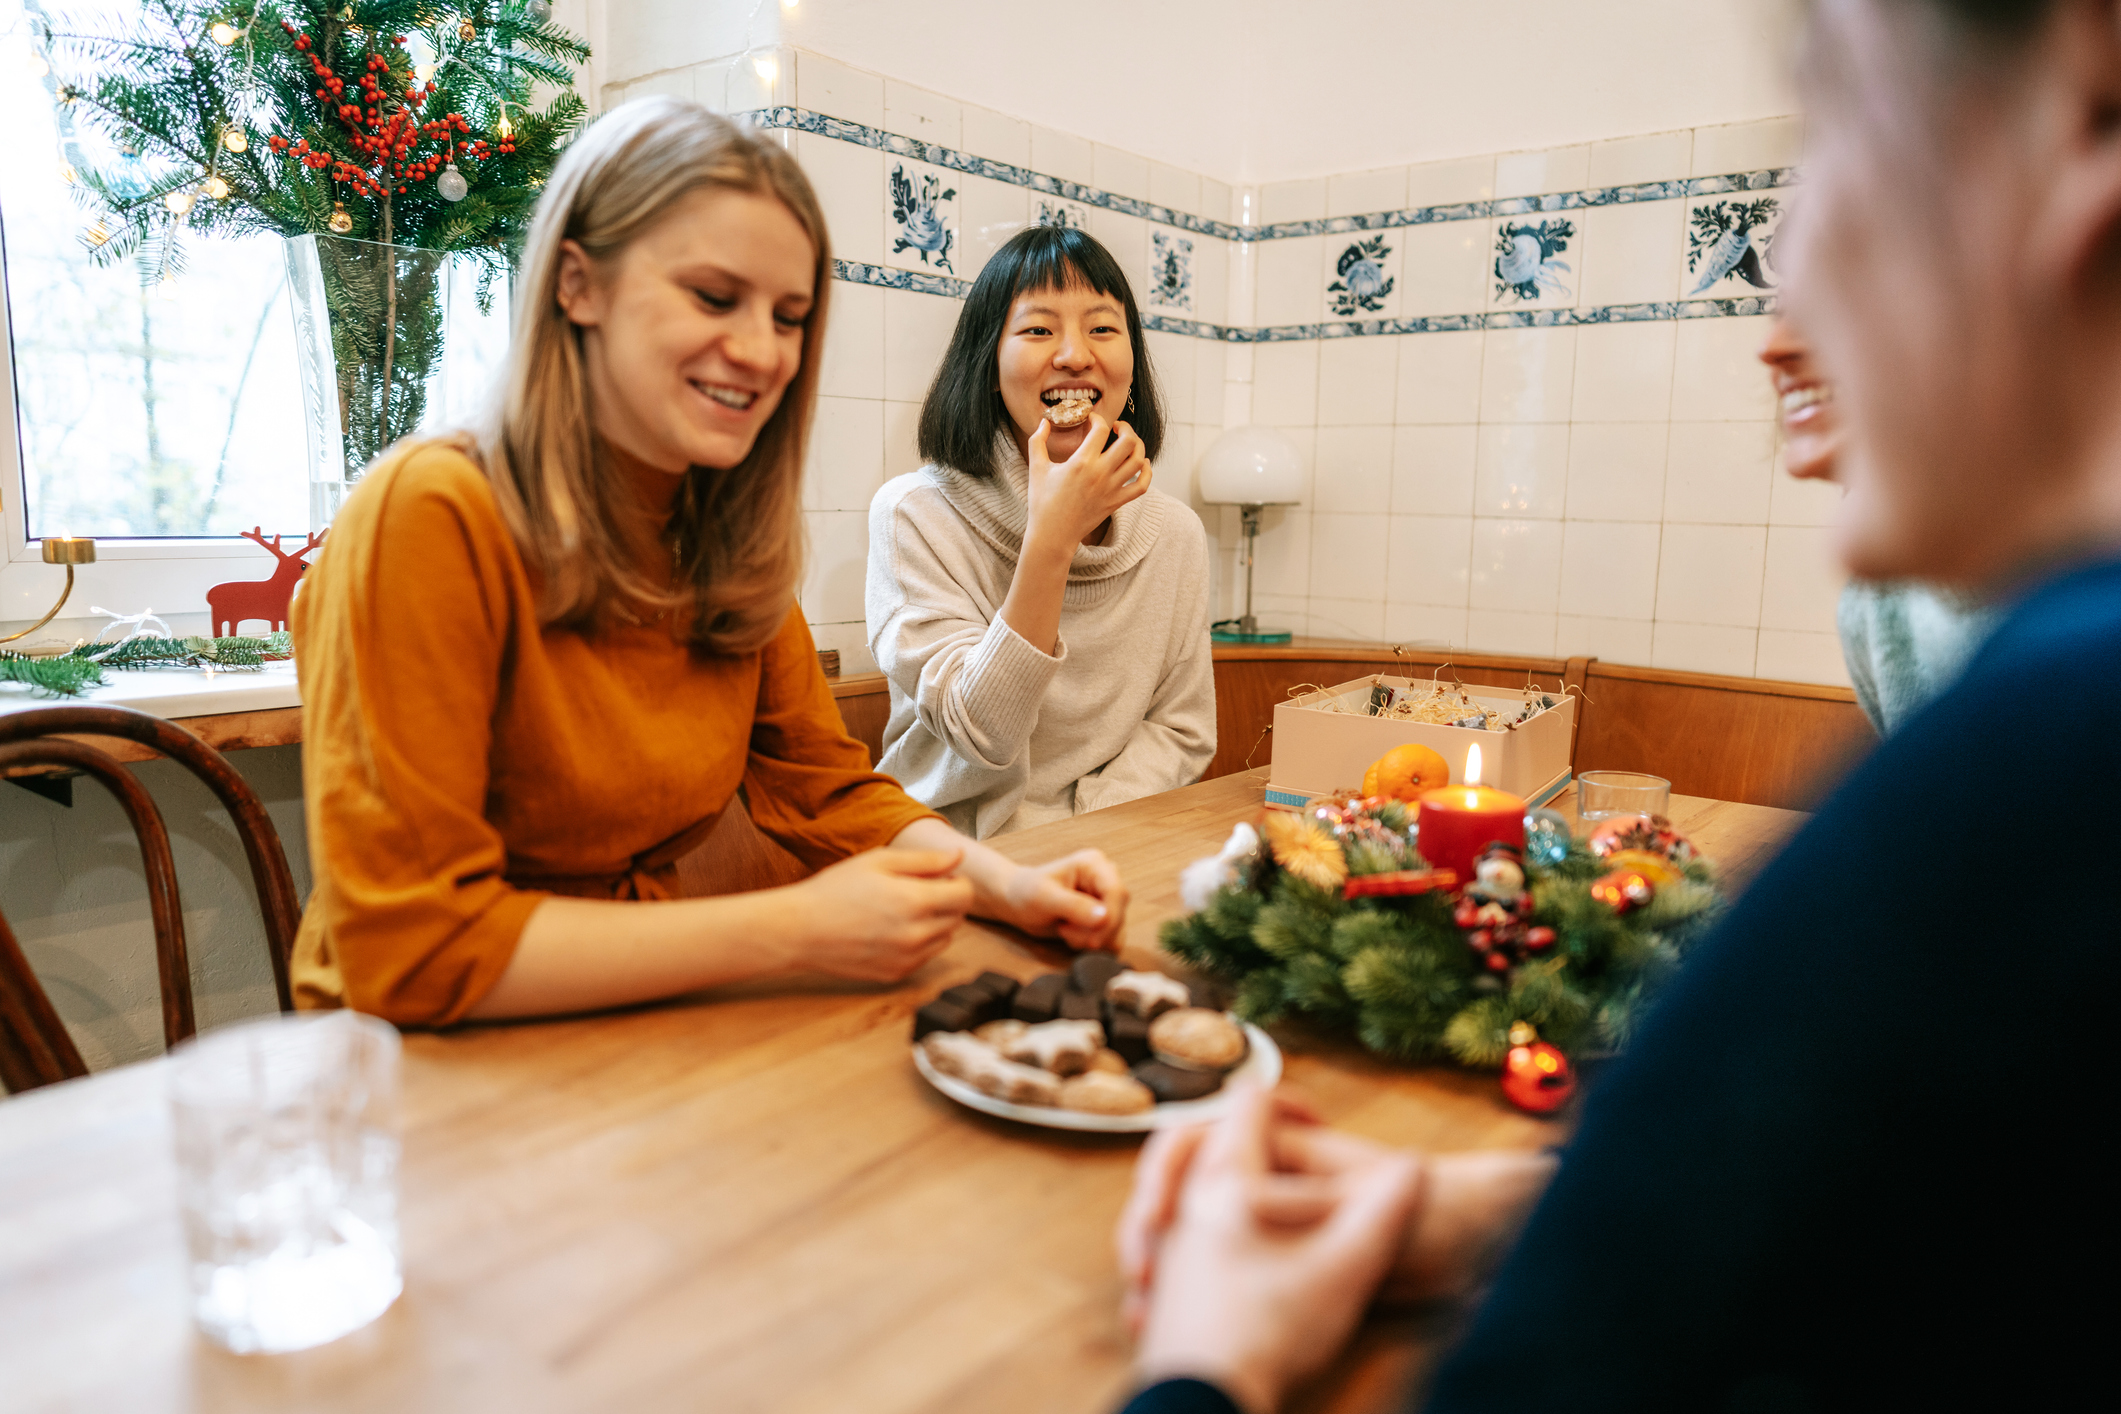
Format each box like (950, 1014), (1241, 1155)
(0, 772), (1801, 1414)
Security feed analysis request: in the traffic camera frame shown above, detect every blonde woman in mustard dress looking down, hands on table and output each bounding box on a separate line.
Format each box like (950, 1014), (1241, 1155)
(295, 98), (1126, 1026)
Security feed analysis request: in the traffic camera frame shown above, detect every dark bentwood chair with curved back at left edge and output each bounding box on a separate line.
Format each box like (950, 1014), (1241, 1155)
(0, 706), (301, 1092)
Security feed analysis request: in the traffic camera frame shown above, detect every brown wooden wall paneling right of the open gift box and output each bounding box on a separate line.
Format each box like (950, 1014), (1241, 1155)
(1576, 661), (1877, 810)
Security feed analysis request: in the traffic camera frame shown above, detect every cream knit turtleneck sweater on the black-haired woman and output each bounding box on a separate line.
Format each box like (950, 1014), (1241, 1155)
(867, 437), (1215, 839)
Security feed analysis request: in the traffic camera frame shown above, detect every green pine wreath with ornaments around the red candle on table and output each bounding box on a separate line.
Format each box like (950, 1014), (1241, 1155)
(1162, 797), (1722, 1102)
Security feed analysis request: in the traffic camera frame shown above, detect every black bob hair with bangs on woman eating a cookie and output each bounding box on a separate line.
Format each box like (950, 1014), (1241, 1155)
(921, 227), (1164, 477)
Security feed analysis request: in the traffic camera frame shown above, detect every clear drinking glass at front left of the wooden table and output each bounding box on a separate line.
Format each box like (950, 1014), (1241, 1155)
(170, 1011), (403, 1355)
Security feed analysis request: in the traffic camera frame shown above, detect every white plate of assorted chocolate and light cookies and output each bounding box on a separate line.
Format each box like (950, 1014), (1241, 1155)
(914, 954), (1281, 1134)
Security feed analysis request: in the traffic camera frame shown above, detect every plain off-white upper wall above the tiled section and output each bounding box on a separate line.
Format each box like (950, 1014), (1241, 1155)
(759, 0), (1796, 182)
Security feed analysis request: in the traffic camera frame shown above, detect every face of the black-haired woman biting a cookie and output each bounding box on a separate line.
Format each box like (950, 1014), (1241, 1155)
(995, 280), (1135, 462)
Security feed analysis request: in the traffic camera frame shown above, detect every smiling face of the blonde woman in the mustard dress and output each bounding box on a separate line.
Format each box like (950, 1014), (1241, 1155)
(558, 191), (817, 473)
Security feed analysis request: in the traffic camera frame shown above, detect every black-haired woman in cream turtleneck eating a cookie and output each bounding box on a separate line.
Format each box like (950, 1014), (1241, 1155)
(867, 227), (1215, 839)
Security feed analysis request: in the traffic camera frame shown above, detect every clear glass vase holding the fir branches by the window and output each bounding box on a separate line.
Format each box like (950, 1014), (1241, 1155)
(286, 235), (509, 530)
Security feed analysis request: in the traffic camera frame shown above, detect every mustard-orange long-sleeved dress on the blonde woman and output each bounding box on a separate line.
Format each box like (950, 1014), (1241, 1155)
(291, 443), (933, 1026)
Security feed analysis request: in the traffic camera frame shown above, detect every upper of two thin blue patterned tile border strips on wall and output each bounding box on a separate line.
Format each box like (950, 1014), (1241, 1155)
(730, 106), (1796, 242)
